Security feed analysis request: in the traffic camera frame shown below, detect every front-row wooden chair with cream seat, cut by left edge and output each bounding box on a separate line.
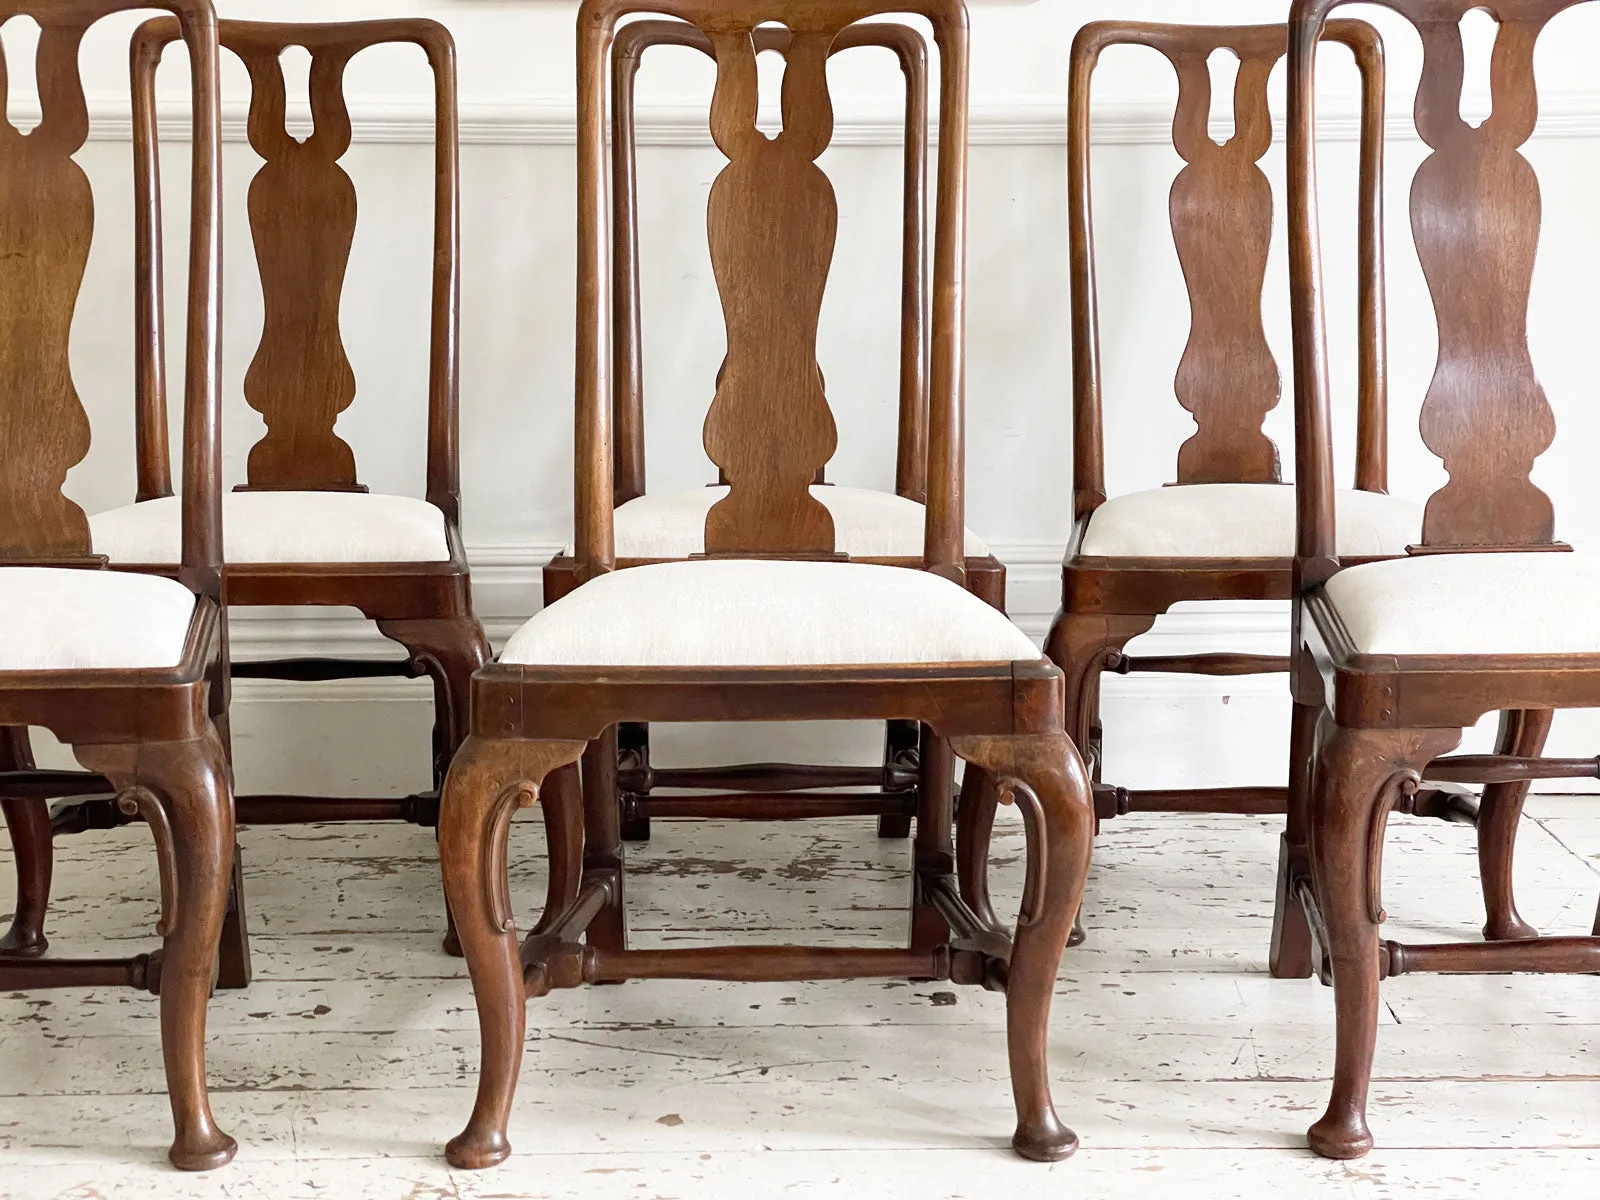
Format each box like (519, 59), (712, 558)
(0, 0), (237, 1170)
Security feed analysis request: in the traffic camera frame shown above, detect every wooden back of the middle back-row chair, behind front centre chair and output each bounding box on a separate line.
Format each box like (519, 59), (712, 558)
(611, 19), (928, 504)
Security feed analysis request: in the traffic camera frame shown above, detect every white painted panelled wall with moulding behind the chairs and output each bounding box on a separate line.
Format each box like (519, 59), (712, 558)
(9, 0), (1600, 790)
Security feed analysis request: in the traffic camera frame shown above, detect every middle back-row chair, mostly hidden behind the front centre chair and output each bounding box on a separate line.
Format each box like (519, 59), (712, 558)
(544, 19), (1005, 842)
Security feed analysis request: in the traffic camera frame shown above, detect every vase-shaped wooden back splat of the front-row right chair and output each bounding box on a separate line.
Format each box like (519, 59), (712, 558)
(1394, 0), (1570, 547)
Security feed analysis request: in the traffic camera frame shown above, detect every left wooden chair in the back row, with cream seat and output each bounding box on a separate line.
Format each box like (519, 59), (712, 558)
(4, 18), (488, 987)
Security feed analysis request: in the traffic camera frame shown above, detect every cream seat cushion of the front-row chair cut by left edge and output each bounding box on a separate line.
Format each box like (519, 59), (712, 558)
(0, 566), (195, 670)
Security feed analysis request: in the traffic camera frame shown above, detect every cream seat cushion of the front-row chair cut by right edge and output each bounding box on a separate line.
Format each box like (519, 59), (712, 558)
(1325, 552), (1600, 654)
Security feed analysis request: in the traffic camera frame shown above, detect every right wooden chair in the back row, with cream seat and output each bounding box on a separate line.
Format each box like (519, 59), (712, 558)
(963, 21), (1547, 978)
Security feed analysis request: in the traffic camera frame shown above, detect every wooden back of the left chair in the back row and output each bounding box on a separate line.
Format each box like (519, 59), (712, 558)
(133, 18), (461, 523)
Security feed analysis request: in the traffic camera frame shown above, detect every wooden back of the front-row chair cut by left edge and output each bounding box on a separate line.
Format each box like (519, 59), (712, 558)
(0, 0), (222, 600)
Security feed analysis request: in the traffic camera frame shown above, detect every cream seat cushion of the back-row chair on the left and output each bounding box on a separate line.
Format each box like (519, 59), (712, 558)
(90, 491), (450, 563)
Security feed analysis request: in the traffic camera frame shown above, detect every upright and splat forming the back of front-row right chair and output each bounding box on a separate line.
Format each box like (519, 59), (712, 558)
(1288, 0), (1589, 587)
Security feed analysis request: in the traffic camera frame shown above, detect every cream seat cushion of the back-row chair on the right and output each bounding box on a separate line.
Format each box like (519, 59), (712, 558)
(1082, 483), (1422, 558)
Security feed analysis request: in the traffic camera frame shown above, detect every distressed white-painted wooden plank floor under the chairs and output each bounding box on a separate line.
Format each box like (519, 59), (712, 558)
(0, 797), (1600, 1200)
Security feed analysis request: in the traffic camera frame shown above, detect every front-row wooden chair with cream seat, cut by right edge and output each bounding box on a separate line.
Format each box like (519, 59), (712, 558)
(1278, 0), (1600, 1158)
